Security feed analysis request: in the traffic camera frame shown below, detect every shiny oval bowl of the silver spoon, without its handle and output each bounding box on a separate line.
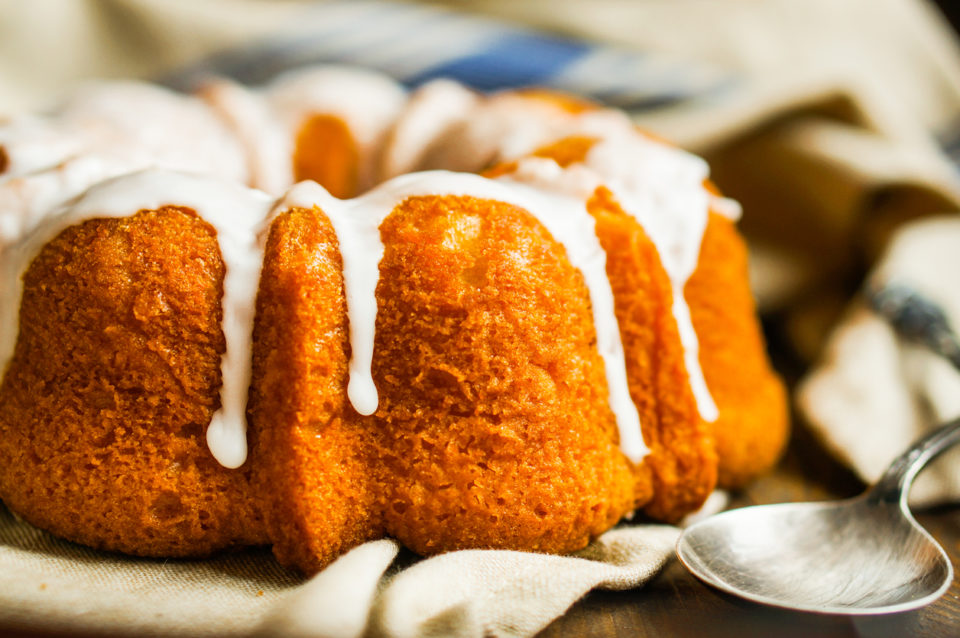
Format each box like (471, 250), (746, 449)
(677, 497), (953, 614)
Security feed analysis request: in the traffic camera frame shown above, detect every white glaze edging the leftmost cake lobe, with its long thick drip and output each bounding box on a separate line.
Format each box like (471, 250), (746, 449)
(0, 170), (273, 467)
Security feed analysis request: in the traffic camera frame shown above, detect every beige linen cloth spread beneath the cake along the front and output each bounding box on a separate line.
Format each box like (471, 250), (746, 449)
(0, 507), (679, 638)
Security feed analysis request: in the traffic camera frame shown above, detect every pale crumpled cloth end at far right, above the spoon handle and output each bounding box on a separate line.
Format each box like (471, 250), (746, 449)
(797, 215), (960, 505)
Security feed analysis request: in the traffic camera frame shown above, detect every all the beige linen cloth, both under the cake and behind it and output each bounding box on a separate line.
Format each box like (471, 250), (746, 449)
(0, 0), (960, 637)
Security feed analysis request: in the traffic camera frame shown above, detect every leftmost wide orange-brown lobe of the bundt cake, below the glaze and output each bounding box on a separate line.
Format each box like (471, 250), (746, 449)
(0, 207), (266, 556)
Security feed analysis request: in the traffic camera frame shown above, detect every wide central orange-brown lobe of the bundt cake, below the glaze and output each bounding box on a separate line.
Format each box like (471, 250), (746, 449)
(374, 196), (636, 554)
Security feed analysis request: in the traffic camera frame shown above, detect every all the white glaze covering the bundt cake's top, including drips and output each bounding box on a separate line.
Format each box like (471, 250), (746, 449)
(0, 74), (739, 467)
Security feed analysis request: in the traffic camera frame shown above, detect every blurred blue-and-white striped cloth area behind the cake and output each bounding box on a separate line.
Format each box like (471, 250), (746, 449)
(165, 0), (734, 110)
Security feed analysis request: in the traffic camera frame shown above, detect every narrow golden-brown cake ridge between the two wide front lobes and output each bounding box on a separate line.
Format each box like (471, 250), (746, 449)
(248, 208), (383, 573)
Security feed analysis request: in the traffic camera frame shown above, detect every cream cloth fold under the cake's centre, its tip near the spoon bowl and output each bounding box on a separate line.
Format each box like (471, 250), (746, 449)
(371, 525), (679, 638)
